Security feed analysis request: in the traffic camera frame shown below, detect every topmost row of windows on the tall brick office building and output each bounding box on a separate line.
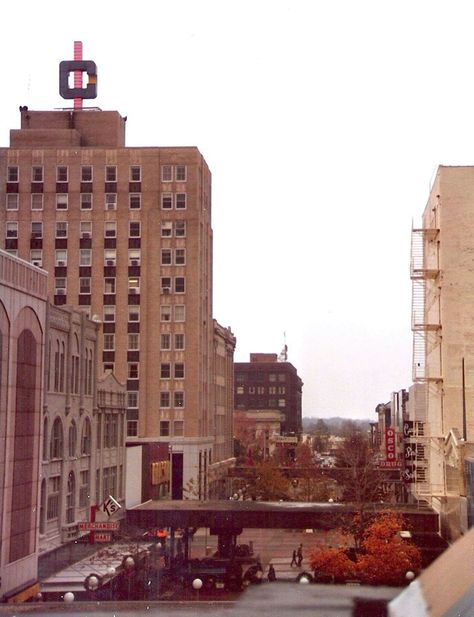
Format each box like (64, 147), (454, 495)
(7, 165), (187, 182)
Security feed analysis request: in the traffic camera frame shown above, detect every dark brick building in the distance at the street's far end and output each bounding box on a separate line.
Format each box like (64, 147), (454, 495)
(234, 353), (303, 435)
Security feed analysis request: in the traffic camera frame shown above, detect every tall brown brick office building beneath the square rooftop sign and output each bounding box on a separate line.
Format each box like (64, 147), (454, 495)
(0, 107), (235, 498)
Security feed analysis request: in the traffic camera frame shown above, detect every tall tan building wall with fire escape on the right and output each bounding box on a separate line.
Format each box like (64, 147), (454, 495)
(412, 167), (474, 536)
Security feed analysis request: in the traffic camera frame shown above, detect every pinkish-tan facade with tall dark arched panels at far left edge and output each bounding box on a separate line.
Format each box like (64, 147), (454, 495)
(0, 250), (46, 601)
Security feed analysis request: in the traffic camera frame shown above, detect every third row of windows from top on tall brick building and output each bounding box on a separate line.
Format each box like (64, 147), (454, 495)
(5, 221), (186, 239)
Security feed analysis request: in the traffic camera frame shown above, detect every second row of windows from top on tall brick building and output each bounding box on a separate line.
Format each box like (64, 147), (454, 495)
(5, 193), (187, 210)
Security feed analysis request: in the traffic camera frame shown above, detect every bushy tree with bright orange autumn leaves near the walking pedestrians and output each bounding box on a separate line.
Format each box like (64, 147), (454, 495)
(310, 512), (421, 585)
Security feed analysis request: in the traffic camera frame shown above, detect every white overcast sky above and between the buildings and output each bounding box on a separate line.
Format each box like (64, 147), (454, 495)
(0, 0), (474, 418)
